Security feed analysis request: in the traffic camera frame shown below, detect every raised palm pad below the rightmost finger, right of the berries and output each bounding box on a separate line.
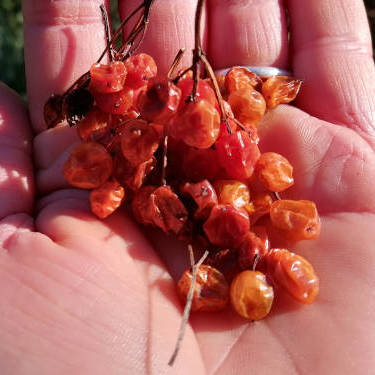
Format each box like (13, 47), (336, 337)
(259, 105), (375, 214)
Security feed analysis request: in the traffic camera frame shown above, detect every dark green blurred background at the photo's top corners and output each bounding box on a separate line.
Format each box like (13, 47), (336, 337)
(0, 0), (375, 97)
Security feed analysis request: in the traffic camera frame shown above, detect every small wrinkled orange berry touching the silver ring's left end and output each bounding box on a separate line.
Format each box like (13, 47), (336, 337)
(225, 66), (262, 94)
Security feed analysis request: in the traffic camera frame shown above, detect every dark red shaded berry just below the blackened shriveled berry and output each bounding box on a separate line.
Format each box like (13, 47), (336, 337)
(77, 107), (110, 141)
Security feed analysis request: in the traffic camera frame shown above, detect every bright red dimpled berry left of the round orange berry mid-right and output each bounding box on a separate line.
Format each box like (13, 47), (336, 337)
(215, 130), (260, 181)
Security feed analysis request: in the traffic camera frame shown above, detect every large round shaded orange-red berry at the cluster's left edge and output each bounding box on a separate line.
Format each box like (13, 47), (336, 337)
(64, 142), (113, 189)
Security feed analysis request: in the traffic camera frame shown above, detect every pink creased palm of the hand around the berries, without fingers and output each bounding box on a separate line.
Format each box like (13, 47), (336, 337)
(0, 0), (375, 374)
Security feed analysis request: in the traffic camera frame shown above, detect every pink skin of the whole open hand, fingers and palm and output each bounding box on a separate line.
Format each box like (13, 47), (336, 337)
(0, 0), (375, 375)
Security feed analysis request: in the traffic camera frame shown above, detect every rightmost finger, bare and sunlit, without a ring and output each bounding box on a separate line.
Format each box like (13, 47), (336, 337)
(289, 0), (375, 146)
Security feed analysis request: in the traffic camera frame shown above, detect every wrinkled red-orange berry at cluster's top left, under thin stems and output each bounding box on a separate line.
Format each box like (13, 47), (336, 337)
(90, 61), (126, 94)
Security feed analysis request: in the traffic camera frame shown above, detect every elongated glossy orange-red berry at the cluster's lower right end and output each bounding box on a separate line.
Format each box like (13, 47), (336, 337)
(265, 249), (319, 304)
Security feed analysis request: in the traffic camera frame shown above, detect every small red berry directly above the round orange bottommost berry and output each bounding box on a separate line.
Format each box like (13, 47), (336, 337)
(238, 227), (269, 269)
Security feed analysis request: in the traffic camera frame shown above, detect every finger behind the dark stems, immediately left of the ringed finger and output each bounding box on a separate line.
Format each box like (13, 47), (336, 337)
(119, 0), (206, 74)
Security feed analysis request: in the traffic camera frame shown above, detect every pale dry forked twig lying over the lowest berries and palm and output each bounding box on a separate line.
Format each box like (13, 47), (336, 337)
(168, 245), (209, 366)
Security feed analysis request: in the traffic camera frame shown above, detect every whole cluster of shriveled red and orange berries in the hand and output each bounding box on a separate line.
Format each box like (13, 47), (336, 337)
(53, 53), (320, 320)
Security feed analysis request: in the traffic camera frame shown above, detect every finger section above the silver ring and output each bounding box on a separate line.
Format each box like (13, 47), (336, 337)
(209, 0), (288, 69)
